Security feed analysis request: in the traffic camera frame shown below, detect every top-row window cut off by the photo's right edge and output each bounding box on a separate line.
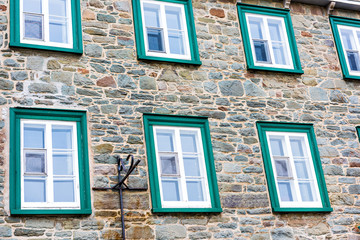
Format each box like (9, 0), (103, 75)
(330, 16), (360, 79)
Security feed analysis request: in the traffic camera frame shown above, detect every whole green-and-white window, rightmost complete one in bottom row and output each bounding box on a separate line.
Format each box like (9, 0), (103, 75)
(256, 122), (333, 212)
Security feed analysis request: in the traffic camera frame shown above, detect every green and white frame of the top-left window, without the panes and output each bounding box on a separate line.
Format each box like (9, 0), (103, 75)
(9, 0), (83, 54)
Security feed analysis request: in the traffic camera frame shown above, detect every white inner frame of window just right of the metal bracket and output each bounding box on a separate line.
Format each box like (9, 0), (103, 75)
(153, 126), (211, 208)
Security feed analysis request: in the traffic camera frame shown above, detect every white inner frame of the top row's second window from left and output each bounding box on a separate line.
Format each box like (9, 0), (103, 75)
(140, 0), (191, 60)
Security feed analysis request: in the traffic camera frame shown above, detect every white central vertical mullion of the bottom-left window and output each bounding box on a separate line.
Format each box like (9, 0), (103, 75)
(45, 123), (54, 204)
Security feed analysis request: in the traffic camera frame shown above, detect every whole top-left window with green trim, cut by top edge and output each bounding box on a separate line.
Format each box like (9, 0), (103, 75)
(10, 0), (82, 53)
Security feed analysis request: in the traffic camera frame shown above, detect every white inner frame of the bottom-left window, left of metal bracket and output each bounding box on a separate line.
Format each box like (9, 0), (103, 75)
(20, 119), (80, 209)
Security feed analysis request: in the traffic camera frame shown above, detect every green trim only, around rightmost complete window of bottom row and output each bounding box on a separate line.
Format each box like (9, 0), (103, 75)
(256, 121), (332, 212)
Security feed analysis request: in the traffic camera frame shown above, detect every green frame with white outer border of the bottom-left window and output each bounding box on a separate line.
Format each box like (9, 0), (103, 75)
(9, 108), (91, 215)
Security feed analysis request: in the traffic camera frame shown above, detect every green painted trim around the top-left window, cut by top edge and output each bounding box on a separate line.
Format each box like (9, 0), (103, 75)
(9, 0), (83, 54)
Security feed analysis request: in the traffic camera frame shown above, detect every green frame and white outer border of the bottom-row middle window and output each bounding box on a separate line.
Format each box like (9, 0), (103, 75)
(143, 113), (222, 213)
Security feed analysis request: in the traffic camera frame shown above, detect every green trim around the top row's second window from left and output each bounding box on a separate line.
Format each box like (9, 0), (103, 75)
(132, 0), (201, 65)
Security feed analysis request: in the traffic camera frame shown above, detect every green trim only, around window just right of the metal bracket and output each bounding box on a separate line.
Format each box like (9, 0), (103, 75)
(143, 113), (222, 212)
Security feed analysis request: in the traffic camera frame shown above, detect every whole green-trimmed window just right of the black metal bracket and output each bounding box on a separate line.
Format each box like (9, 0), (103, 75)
(144, 114), (222, 212)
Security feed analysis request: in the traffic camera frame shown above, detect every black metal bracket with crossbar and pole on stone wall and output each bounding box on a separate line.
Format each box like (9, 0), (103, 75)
(92, 154), (147, 240)
